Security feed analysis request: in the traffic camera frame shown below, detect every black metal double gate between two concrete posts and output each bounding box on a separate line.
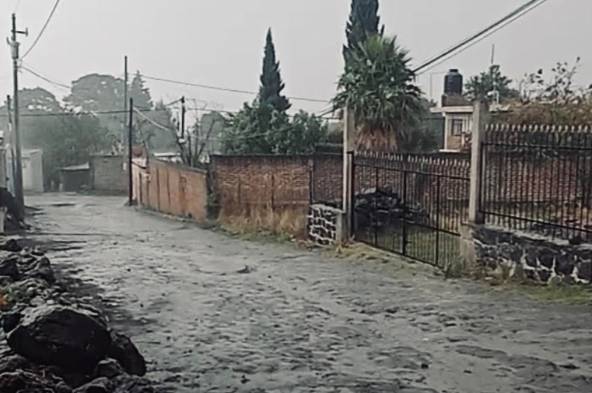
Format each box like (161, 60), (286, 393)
(352, 154), (470, 268)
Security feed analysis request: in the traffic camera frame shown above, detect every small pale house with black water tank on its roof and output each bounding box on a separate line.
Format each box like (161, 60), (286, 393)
(430, 69), (508, 152)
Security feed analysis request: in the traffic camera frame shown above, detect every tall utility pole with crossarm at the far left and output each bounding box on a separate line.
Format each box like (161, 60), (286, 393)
(10, 14), (28, 219)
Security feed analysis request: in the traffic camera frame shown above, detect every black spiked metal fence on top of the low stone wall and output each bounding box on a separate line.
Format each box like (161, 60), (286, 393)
(480, 125), (592, 241)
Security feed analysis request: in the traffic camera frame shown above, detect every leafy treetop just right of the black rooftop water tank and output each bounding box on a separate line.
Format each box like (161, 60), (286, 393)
(466, 65), (518, 102)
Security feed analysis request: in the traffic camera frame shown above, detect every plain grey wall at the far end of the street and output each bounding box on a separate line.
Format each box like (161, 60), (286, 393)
(90, 156), (128, 193)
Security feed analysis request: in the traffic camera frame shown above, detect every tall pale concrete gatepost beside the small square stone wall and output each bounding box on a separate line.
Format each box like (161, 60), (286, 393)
(343, 108), (356, 238)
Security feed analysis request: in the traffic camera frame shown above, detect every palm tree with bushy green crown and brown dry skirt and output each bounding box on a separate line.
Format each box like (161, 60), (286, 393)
(333, 35), (425, 152)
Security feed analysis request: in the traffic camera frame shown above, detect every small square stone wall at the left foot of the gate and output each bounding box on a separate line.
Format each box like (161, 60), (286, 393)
(308, 205), (345, 246)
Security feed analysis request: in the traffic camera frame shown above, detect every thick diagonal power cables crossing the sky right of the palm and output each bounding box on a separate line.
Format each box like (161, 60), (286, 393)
(413, 0), (547, 75)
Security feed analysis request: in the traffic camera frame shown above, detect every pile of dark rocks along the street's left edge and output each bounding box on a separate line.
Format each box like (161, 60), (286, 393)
(0, 240), (156, 393)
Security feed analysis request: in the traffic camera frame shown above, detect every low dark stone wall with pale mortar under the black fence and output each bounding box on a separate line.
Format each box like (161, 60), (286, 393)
(463, 226), (592, 284)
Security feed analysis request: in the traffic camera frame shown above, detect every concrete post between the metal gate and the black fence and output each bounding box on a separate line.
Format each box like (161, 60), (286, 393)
(469, 101), (489, 225)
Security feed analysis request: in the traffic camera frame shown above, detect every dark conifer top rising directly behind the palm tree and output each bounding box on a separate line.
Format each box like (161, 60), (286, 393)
(343, 0), (384, 65)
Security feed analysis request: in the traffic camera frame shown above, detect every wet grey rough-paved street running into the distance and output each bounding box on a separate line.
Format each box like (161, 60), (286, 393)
(28, 195), (592, 393)
